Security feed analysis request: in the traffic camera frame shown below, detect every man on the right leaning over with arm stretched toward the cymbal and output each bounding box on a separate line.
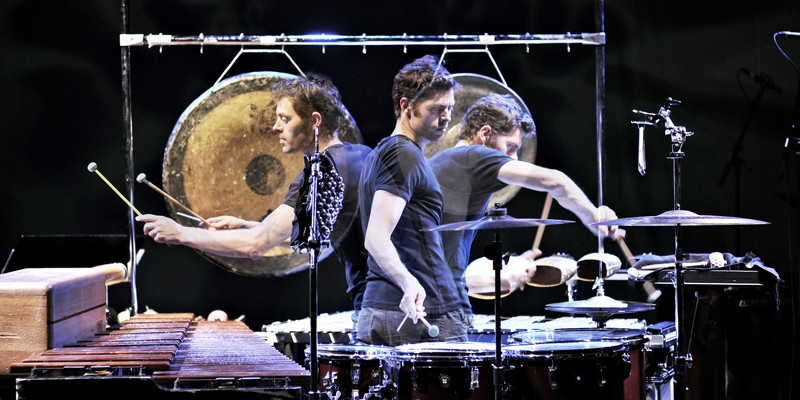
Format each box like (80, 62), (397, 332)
(430, 93), (624, 310)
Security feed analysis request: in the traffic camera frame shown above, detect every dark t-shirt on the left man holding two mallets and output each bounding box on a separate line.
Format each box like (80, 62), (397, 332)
(283, 142), (371, 310)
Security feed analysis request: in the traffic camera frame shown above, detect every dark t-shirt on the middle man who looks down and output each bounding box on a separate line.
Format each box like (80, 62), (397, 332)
(360, 135), (461, 315)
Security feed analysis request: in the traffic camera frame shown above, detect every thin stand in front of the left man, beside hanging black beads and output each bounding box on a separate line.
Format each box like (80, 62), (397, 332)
(308, 129), (322, 400)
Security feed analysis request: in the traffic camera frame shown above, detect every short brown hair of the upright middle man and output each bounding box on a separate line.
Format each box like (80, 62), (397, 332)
(392, 55), (461, 118)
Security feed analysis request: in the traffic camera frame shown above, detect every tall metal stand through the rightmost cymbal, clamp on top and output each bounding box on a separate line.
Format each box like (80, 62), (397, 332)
(631, 97), (694, 399)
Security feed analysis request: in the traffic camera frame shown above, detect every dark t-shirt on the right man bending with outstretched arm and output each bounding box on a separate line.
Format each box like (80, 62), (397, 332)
(430, 145), (513, 306)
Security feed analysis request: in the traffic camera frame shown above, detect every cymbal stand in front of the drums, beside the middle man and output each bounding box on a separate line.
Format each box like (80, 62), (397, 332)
(483, 207), (509, 400)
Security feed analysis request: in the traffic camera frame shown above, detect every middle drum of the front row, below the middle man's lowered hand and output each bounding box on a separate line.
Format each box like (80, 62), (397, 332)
(395, 342), (496, 400)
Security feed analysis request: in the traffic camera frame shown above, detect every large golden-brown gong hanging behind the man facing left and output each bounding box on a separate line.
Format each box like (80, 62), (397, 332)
(163, 72), (361, 277)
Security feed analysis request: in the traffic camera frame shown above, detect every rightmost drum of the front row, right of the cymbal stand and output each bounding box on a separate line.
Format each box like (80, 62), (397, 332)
(503, 342), (630, 400)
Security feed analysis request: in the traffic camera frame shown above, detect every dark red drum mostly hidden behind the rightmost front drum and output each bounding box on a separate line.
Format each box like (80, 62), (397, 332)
(512, 329), (647, 400)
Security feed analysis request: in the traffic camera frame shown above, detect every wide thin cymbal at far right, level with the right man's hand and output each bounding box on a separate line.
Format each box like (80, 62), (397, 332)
(592, 210), (769, 226)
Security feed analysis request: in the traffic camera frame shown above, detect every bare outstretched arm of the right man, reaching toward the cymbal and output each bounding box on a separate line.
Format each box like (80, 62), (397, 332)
(497, 161), (624, 237)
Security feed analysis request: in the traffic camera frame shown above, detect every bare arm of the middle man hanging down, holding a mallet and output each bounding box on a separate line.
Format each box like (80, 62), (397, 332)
(364, 190), (426, 323)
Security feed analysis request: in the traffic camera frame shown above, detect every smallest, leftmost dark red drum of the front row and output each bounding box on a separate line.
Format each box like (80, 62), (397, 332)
(306, 344), (394, 400)
